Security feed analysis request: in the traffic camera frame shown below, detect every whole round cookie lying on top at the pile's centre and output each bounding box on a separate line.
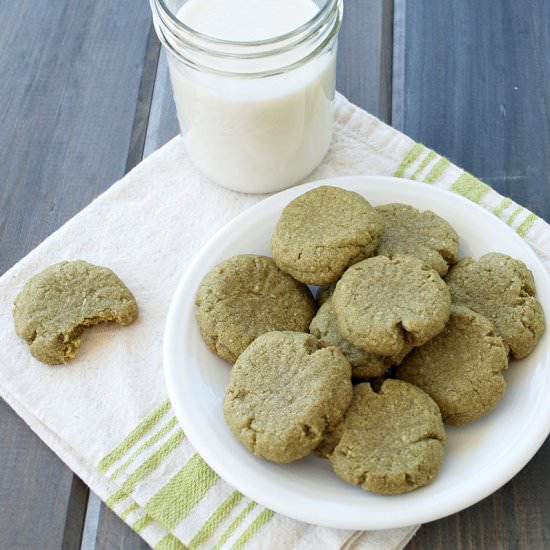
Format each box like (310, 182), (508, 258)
(332, 256), (451, 355)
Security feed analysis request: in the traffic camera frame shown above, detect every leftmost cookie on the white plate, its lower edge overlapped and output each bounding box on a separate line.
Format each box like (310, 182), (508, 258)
(195, 254), (316, 363)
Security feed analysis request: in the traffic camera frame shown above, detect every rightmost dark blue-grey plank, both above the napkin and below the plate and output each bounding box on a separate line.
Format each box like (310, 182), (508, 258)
(392, 0), (550, 550)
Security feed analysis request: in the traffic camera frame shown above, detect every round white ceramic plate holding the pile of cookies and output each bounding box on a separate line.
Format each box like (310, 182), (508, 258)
(164, 177), (550, 529)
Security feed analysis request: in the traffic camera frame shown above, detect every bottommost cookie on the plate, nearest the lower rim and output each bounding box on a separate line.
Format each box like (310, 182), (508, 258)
(328, 380), (446, 495)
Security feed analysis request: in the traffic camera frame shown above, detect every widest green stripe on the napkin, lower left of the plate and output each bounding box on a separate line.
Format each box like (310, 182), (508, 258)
(145, 454), (218, 530)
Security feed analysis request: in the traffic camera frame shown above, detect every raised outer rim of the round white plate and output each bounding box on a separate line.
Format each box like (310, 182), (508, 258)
(162, 175), (550, 530)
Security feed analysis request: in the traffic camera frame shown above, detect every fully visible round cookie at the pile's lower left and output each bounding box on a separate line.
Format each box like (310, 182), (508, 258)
(223, 331), (353, 463)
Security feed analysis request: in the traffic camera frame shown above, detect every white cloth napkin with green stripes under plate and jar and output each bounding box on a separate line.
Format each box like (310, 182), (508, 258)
(0, 96), (550, 550)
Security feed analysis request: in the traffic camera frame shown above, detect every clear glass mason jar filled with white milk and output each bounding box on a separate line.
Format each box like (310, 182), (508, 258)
(151, 0), (342, 193)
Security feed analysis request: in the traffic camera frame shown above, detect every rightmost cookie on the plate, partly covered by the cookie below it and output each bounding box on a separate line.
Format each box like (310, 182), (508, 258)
(446, 252), (545, 359)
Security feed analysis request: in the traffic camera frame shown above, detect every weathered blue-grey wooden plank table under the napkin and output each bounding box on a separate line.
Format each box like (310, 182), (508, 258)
(0, 0), (550, 550)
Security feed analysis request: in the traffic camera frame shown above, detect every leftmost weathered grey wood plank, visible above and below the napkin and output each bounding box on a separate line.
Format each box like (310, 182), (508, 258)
(0, 0), (155, 549)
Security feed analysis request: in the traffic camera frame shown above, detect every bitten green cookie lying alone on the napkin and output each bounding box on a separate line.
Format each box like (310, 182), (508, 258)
(13, 260), (138, 365)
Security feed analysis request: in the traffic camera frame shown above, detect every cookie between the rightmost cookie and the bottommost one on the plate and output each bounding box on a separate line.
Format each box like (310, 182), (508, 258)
(397, 306), (508, 426)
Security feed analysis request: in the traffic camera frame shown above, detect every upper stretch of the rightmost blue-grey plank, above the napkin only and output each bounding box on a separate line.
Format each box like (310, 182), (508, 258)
(393, 0), (550, 219)
